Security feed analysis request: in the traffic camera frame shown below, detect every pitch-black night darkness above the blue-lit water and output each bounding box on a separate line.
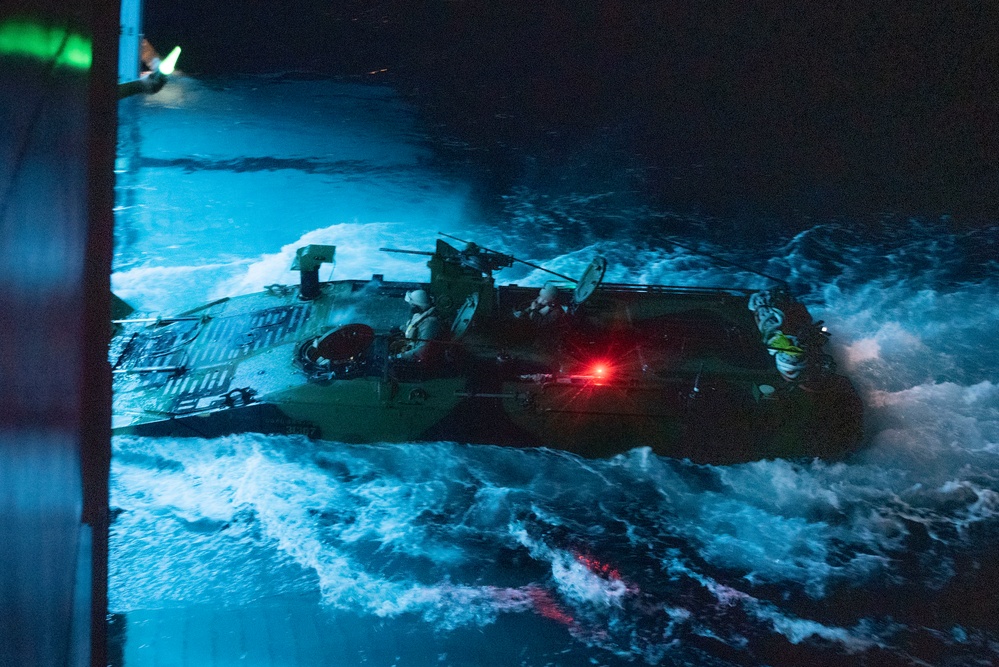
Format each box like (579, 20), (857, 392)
(146, 0), (999, 224)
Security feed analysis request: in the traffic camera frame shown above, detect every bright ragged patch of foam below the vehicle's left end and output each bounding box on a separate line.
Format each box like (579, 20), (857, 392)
(112, 435), (548, 629)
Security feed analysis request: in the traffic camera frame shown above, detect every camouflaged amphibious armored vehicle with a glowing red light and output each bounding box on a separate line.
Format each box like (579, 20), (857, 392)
(111, 235), (862, 462)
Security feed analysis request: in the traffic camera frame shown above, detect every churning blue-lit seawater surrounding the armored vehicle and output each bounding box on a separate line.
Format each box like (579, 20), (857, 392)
(110, 77), (999, 665)
